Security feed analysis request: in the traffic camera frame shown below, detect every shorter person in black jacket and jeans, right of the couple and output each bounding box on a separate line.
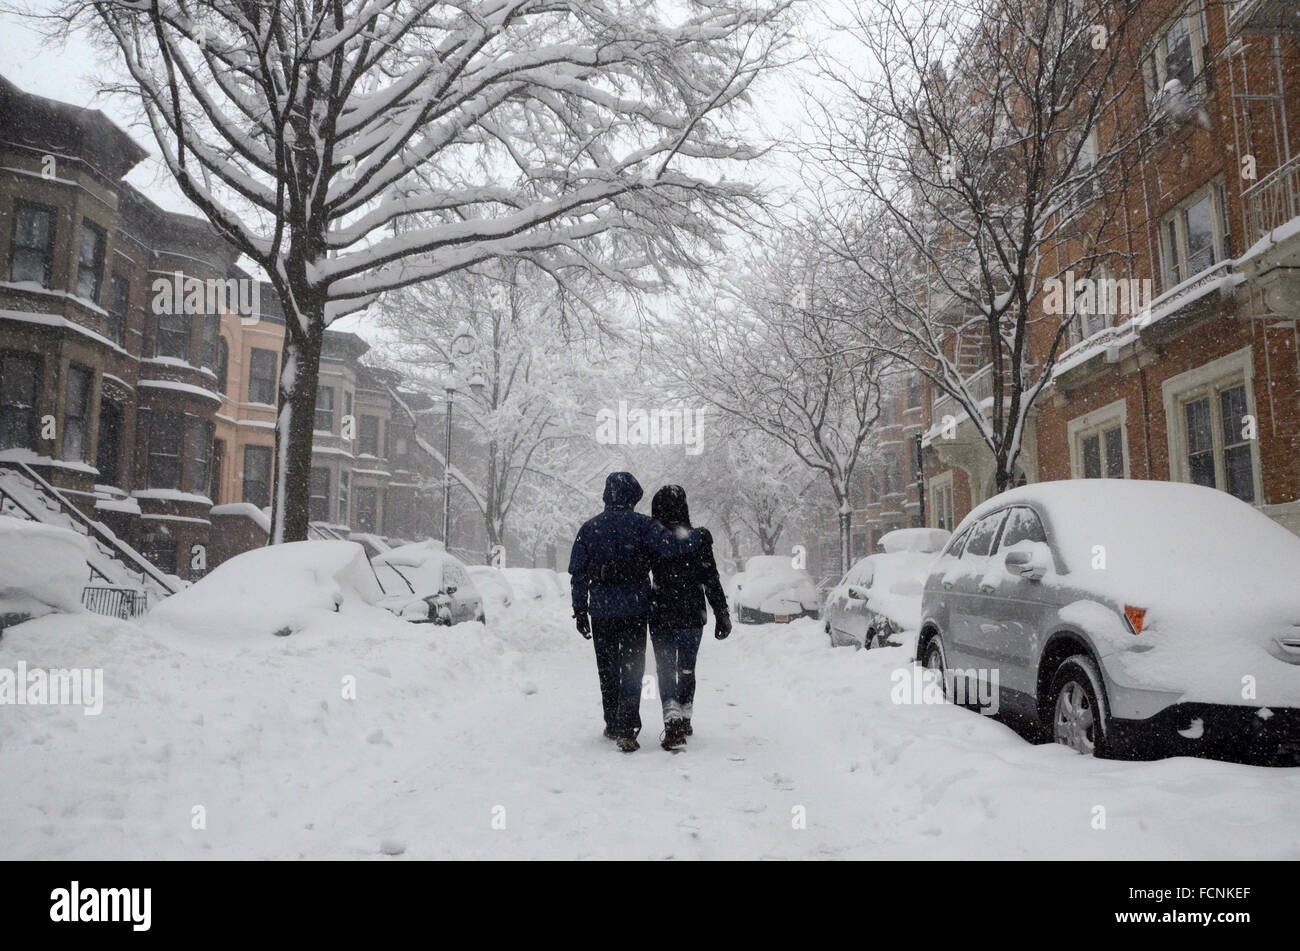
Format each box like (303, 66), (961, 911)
(650, 486), (731, 750)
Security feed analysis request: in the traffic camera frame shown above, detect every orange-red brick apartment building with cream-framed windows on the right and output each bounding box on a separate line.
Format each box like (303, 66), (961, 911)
(923, 0), (1300, 543)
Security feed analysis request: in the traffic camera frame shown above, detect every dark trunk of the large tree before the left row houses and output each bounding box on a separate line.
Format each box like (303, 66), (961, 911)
(269, 323), (324, 544)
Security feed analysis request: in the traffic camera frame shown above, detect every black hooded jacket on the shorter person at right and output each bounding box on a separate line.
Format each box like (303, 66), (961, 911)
(650, 486), (729, 630)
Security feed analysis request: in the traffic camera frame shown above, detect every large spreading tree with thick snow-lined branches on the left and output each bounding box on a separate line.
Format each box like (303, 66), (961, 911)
(45, 0), (790, 542)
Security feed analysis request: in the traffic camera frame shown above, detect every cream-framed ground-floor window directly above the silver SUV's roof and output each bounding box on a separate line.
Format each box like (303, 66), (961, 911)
(1164, 348), (1260, 503)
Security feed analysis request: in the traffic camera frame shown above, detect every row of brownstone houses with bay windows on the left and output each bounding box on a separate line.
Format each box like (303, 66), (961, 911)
(0, 78), (441, 595)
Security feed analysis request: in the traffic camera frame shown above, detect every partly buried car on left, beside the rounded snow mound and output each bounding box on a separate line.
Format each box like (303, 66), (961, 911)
(371, 539), (486, 625)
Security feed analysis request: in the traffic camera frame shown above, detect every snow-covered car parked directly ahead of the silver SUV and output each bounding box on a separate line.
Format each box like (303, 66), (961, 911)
(822, 529), (952, 647)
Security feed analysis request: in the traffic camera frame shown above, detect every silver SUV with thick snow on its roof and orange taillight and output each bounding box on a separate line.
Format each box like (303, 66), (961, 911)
(917, 479), (1300, 764)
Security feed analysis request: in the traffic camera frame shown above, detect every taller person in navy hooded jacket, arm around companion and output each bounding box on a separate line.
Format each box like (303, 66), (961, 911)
(569, 472), (703, 752)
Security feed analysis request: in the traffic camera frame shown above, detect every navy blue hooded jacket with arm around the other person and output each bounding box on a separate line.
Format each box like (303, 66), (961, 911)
(569, 472), (703, 618)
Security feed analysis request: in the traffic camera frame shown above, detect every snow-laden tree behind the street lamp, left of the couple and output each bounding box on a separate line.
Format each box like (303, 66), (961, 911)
(380, 261), (614, 550)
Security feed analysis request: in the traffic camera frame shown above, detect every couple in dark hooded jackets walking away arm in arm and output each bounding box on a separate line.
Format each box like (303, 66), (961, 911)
(569, 472), (731, 752)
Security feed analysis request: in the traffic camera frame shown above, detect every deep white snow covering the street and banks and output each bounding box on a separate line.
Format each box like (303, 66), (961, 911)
(0, 599), (1300, 859)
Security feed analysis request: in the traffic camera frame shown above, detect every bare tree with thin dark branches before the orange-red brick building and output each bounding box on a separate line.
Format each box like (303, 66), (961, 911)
(814, 0), (1152, 491)
